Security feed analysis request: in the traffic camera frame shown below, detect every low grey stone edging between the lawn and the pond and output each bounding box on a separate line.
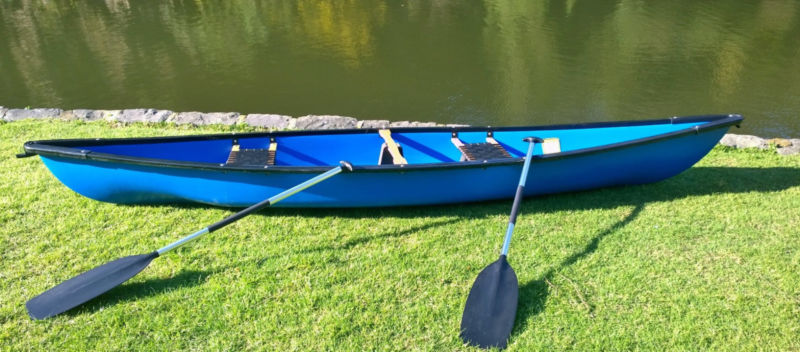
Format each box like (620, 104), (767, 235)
(0, 106), (800, 155)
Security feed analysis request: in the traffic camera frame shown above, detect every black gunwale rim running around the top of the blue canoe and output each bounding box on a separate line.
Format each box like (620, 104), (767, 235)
(21, 114), (743, 173)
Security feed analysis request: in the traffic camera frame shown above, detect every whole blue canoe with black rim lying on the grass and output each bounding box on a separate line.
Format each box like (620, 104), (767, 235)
(24, 115), (742, 207)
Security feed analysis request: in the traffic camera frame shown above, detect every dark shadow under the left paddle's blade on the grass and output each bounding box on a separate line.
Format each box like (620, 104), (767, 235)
(64, 270), (219, 316)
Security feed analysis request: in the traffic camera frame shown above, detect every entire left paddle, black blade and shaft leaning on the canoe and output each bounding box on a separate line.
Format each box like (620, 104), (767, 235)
(25, 161), (353, 319)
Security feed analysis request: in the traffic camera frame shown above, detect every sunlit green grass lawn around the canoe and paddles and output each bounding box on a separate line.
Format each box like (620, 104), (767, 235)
(0, 121), (800, 351)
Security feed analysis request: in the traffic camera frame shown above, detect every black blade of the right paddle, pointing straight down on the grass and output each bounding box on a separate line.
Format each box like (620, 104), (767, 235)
(461, 255), (519, 349)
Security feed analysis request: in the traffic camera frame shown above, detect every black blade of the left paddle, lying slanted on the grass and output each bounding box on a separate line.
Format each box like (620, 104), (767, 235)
(25, 252), (158, 320)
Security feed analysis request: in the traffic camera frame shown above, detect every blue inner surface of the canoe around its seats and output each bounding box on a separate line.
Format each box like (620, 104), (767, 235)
(72, 121), (708, 166)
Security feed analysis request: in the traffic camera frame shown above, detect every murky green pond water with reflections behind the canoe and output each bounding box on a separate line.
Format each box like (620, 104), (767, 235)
(0, 0), (800, 137)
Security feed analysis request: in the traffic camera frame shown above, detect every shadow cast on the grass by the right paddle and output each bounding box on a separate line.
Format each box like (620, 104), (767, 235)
(511, 204), (644, 336)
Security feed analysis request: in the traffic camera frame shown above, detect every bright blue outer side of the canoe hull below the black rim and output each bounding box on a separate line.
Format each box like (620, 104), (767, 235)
(40, 126), (729, 207)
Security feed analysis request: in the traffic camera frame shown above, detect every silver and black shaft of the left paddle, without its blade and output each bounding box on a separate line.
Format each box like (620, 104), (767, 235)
(156, 162), (349, 255)
